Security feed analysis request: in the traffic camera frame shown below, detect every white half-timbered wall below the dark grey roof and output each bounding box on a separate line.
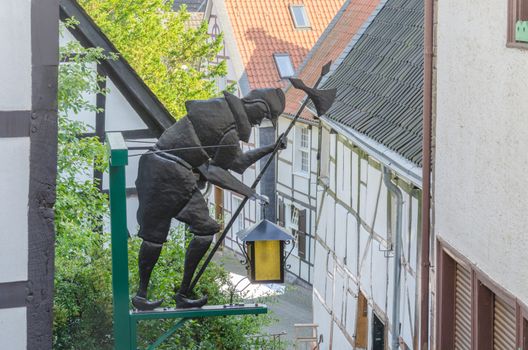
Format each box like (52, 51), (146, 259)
(314, 124), (420, 349)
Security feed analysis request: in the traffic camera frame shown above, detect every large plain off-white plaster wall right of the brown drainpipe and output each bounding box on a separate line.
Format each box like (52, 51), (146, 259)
(434, 0), (528, 303)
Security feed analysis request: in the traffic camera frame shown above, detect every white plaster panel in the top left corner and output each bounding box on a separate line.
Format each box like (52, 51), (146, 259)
(0, 0), (31, 111)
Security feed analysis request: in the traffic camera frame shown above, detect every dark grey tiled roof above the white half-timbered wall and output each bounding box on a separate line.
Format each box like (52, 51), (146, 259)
(323, 0), (424, 166)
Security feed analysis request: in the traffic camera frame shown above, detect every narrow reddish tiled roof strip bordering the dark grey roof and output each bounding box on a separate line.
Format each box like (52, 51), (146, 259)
(284, 0), (379, 120)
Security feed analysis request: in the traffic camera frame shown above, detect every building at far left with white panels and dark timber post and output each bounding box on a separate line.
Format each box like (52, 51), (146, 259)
(0, 0), (59, 350)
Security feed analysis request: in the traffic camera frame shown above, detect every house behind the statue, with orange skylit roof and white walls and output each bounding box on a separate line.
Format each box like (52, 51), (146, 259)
(205, 0), (345, 282)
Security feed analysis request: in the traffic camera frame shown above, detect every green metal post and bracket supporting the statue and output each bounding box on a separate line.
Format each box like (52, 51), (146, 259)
(106, 132), (268, 350)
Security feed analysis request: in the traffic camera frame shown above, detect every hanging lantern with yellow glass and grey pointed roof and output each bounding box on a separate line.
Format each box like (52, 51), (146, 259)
(237, 219), (293, 283)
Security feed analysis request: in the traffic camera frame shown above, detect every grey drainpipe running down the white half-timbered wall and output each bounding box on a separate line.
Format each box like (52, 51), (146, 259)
(383, 166), (403, 350)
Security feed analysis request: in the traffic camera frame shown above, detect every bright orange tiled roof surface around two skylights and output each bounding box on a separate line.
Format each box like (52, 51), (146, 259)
(224, 0), (345, 89)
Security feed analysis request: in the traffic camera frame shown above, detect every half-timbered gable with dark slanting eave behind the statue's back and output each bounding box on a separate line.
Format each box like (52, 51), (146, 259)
(60, 0), (175, 234)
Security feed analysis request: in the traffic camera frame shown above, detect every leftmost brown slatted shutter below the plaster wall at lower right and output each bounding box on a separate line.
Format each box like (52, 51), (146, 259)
(455, 264), (471, 350)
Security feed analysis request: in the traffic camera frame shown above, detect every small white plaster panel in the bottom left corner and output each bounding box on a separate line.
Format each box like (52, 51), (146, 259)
(0, 307), (27, 350)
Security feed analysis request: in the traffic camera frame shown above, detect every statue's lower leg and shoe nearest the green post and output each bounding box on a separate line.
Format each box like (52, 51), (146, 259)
(132, 241), (163, 311)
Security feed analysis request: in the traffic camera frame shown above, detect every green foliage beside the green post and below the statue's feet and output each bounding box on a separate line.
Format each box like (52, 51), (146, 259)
(53, 21), (284, 350)
